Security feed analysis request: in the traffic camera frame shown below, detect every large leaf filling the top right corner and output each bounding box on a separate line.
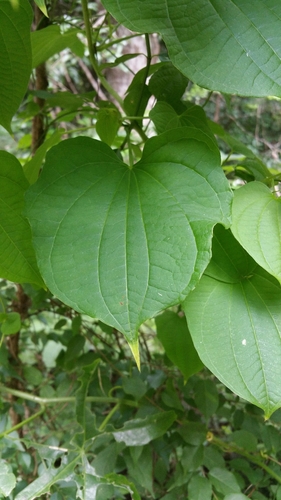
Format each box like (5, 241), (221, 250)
(103, 0), (281, 96)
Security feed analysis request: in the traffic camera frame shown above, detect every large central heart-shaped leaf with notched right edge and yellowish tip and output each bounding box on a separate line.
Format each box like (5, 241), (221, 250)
(26, 131), (232, 362)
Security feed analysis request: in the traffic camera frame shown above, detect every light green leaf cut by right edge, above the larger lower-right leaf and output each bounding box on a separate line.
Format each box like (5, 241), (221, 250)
(231, 182), (281, 282)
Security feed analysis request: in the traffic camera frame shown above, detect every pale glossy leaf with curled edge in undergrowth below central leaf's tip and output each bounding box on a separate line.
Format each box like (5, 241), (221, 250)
(113, 411), (176, 446)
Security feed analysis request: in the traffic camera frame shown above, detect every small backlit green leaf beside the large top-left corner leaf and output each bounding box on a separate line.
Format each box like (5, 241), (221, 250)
(31, 25), (84, 68)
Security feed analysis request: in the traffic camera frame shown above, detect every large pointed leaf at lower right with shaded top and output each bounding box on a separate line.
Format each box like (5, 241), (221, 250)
(184, 226), (281, 417)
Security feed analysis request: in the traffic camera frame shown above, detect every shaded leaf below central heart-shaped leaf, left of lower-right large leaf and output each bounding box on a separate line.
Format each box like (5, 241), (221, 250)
(155, 311), (204, 380)
